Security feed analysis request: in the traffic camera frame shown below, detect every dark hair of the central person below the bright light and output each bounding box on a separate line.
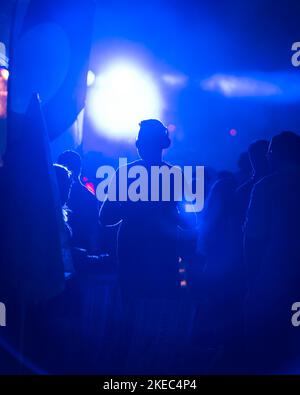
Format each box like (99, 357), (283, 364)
(136, 119), (171, 149)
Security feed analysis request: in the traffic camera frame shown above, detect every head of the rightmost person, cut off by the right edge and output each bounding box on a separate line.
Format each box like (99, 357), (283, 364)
(268, 132), (300, 170)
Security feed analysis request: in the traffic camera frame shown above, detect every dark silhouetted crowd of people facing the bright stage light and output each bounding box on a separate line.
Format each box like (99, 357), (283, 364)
(2, 120), (300, 374)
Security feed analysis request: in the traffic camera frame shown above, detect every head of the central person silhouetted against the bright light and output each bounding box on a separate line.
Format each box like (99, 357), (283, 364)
(136, 119), (171, 161)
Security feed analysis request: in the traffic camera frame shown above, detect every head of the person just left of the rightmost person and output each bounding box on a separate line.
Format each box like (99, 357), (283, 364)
(248, 140), (269, 176)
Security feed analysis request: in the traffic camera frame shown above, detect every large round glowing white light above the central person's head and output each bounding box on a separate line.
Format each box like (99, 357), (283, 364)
(87, 62), (162, 139)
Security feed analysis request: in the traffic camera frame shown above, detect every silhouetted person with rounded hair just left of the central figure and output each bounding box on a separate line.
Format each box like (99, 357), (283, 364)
(57, 150), (99, 254)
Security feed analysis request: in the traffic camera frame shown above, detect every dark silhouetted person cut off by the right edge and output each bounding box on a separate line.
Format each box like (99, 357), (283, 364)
(244, 132), (300, 373)
